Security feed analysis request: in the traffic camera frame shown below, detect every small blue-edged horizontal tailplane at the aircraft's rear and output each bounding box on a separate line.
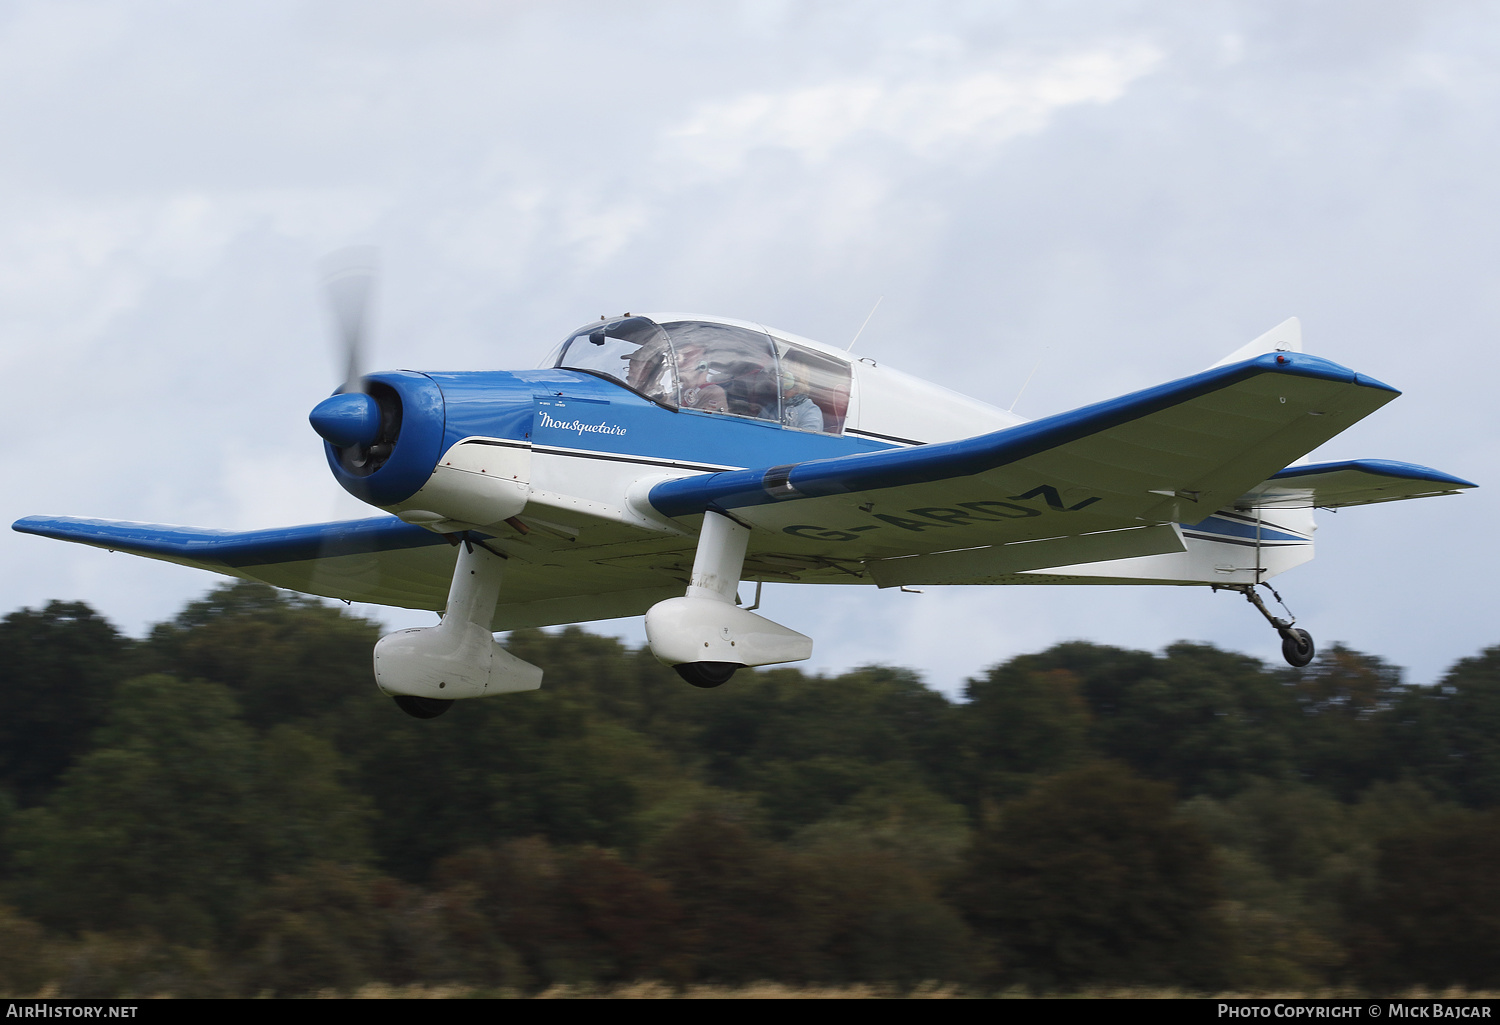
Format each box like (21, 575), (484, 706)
(1236, 459), (1478, 509)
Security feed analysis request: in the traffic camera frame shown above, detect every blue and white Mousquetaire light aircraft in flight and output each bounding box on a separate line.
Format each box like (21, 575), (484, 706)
(15, 261), (1475, 719)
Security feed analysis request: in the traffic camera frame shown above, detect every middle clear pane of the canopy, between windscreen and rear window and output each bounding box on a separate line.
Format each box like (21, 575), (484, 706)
(662, 321), (782, 422)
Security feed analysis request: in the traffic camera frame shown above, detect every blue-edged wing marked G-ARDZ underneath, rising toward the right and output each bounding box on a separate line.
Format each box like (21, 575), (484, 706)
(650, 353), (1398, 561)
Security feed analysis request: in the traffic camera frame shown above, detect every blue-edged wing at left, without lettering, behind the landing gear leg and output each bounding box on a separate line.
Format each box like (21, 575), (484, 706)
(15, 516), (692, 630)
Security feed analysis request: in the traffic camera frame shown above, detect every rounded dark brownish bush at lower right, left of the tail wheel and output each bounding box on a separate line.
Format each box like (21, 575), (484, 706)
(957, 762), (1230, 990)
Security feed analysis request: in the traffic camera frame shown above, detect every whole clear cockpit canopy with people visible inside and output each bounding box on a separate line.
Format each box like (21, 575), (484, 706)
(551, 317), (849, 434)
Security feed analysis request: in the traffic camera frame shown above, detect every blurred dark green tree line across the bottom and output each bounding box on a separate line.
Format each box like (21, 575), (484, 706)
(0, 584), (1500, 996)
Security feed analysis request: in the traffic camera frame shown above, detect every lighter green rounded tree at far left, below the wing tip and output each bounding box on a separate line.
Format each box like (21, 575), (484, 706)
(11, 674), (365, 944)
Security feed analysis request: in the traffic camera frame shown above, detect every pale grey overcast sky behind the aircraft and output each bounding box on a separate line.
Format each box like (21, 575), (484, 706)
(0, 0), (1500, 692)
